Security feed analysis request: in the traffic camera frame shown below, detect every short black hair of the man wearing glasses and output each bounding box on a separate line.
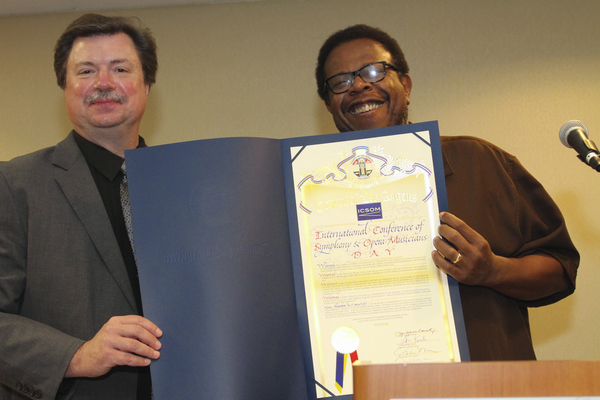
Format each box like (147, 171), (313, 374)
(315, 24), (408, 103)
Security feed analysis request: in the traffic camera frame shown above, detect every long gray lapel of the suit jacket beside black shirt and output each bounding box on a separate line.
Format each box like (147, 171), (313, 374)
(52, 132), (137, 310)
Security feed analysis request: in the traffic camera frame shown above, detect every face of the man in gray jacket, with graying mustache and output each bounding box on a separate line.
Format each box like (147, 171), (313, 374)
(65, 33), (149, 143)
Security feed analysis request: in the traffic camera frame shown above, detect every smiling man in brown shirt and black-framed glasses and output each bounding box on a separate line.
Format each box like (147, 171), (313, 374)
(316, 25), (579, 361)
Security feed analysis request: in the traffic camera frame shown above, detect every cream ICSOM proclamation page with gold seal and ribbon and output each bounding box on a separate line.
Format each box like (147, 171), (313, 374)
(283, 122), (468, 398)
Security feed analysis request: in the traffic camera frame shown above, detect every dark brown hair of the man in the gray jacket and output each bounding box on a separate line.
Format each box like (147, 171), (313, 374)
(54, 14), (158, 89)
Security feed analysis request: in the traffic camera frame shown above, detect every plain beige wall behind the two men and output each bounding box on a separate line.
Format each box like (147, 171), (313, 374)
(0, 0), (600, 359)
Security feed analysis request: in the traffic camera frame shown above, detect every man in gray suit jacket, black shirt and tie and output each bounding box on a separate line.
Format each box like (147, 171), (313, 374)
(0, 14), (162, 400)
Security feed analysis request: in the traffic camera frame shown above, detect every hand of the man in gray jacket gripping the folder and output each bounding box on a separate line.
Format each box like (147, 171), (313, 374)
(65, 315), (162, 378)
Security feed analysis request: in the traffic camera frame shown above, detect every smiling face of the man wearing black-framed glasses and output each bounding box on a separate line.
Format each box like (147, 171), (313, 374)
(325, 39), (412, 132)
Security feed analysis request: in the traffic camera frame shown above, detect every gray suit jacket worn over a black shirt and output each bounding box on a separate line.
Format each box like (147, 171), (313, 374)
(0, 132), (139, 400)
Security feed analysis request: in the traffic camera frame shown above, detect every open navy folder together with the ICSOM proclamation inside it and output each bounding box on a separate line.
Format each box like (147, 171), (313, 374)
(125, 122), (469, 400)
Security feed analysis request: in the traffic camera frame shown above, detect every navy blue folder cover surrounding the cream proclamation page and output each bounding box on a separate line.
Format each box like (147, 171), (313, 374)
(126, 122), (469, 400)
